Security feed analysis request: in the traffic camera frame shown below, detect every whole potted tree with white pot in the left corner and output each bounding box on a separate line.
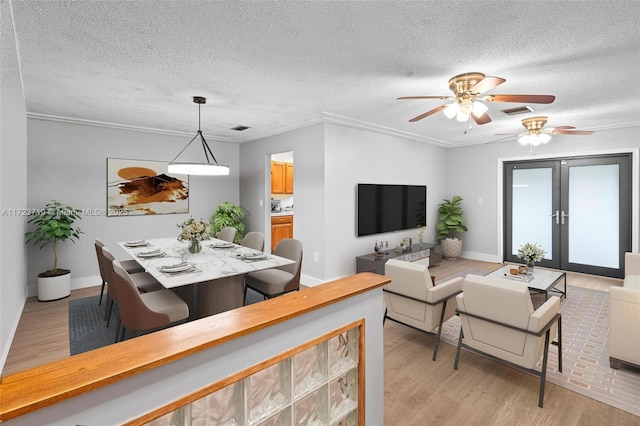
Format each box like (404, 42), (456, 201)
(25, 200), (83, 302)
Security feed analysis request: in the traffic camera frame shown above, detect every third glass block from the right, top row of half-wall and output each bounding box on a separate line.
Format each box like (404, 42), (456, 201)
(246, 359), (291, 423)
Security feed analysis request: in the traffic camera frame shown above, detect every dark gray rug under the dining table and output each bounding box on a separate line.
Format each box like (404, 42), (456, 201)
(69, 289), (264, 355)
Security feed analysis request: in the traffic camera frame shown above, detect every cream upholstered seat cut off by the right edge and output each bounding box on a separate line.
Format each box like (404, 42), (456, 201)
(609, 253), (640, 369)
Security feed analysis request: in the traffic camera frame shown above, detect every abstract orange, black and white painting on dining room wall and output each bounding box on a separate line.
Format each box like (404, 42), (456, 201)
(107, 158), (189, 216)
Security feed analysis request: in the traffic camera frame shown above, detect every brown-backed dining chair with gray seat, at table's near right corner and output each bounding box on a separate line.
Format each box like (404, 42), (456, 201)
(243, 238), (302, 301)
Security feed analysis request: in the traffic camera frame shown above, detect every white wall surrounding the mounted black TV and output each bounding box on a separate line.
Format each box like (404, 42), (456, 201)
(324, 124), (448, 279)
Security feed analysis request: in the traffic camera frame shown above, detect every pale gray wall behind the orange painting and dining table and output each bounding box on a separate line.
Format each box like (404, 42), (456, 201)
(24, 118), (239, 295)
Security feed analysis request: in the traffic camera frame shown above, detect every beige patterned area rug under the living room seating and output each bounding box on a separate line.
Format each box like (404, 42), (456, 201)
(442, 286), (640, 416)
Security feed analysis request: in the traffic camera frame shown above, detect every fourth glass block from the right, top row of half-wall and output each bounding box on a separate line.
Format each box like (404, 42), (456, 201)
(191, 382), (244, 426)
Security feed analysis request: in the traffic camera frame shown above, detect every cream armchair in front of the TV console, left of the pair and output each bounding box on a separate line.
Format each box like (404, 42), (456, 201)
(383, 259), (462, 361)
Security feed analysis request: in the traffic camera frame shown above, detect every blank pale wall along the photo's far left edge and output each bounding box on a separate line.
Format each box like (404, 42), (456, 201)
(0, 1), (27, 371)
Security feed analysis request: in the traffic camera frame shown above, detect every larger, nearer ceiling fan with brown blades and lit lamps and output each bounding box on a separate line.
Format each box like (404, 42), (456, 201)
(398, 72), (556, 125)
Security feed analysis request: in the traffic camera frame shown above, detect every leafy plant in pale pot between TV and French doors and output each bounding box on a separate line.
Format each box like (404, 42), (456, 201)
(436, 195), (467, 260)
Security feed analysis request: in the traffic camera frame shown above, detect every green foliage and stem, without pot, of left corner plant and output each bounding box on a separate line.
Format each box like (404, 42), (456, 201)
(24, 200), (84, 277)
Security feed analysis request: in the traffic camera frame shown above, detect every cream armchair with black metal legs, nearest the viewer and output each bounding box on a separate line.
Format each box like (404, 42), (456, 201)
(453, 274), (562, 408)
